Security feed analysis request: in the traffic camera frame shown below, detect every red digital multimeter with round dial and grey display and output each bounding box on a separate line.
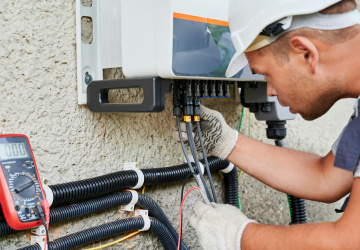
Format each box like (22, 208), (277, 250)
(0, 134), (45, 230)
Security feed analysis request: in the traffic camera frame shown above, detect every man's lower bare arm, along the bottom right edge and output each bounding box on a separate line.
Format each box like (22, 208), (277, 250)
(241, 178), (360, 250)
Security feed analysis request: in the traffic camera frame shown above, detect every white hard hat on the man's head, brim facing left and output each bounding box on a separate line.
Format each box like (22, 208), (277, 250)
(226, 0), (341, 77)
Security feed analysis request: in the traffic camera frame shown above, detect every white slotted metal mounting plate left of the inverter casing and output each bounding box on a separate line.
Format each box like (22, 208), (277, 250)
(76, 0), (122, 104)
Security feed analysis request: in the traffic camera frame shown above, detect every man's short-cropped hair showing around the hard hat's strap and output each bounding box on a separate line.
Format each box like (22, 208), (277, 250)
(257, 0), (359, 62)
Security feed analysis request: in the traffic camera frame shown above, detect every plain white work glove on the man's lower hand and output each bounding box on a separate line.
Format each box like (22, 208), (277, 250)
(190, 201), (256, 250)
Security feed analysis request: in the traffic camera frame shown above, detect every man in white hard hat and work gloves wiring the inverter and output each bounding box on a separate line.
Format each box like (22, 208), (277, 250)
(187, 0), (360, 250)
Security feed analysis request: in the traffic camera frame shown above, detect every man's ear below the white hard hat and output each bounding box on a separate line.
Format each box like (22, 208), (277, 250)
(290, 36), (319, 73)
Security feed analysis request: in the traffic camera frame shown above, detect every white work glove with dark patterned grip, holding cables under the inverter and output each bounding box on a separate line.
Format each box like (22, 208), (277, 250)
(173, 105), (238, 159)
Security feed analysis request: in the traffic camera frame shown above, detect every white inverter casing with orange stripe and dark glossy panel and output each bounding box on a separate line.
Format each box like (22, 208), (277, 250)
(120, 0), (255, 80)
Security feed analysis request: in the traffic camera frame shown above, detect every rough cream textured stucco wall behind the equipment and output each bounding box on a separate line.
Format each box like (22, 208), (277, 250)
(0, 0), (354, 249)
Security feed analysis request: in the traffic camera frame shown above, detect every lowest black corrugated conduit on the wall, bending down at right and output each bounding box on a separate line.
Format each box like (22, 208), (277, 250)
(20, 216), (177, 250)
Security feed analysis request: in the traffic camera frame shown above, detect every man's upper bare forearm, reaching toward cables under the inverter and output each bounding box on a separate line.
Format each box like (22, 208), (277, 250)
(227, 135), (352, 202)
